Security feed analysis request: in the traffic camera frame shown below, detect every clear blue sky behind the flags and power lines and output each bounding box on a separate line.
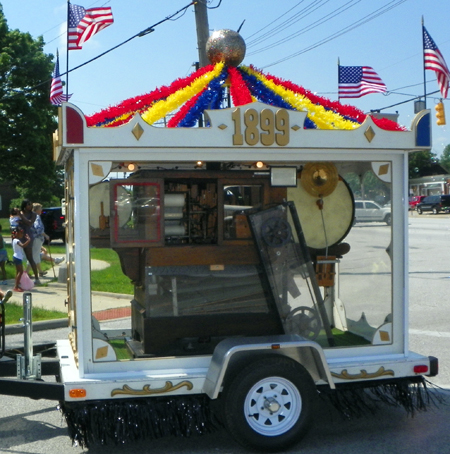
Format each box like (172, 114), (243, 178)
(0, 0), (450, 155)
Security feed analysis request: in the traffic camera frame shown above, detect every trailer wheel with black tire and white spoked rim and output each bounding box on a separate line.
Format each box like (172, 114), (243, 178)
(224, 357), (316, 452)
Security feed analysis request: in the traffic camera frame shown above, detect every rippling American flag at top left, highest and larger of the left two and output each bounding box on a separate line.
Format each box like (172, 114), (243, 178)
(67, 3), (114, 50)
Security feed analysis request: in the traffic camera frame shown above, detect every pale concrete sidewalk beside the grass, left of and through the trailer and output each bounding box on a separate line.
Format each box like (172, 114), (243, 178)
(0, 260), (133, 334)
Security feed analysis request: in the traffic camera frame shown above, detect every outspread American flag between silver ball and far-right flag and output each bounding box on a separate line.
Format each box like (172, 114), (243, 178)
(338, 66), (386, 98)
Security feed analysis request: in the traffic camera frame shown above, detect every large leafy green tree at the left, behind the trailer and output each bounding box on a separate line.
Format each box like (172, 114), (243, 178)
(0, 4), (63, 203)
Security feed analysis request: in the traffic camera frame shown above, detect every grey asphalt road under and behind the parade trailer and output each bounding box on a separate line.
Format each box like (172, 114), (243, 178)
(0, 214), (450, 454)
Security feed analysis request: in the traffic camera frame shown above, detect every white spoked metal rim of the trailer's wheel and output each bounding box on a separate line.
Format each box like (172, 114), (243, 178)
(244, 377), (302, 437)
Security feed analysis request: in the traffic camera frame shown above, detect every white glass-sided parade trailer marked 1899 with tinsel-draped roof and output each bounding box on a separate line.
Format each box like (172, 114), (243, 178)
(2, 30), (438, 451)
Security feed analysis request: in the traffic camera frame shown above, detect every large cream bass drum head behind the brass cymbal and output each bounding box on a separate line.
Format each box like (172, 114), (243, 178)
(287, 177), (355, 249)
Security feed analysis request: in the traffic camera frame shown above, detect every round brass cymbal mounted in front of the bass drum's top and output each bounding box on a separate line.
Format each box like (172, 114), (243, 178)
(300, 162), (339, 197)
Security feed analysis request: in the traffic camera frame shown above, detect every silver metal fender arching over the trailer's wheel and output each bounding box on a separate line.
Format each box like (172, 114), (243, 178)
(203, 334), (335, 399)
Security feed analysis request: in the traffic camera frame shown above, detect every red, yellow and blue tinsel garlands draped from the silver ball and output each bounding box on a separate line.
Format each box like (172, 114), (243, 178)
(87, 62), (405, 131)
